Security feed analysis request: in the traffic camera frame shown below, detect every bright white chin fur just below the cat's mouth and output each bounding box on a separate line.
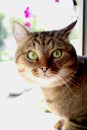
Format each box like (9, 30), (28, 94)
(26, 73), (64, 88)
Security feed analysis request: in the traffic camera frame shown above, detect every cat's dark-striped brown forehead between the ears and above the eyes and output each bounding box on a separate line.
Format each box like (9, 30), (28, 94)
(24, 30), (69, 51)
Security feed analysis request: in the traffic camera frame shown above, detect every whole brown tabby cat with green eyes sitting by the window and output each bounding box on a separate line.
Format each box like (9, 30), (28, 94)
(13, 21), (87, 130)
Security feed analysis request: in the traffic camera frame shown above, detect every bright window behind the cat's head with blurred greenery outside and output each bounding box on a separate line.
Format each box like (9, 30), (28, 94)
(0, 0), (83, 60)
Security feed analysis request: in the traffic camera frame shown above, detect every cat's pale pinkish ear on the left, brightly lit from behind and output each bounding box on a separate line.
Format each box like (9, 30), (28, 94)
(13, 21), (29, 42)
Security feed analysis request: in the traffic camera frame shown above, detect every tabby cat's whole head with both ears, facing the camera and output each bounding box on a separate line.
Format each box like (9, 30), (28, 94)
(13, 22), (77, 87)
